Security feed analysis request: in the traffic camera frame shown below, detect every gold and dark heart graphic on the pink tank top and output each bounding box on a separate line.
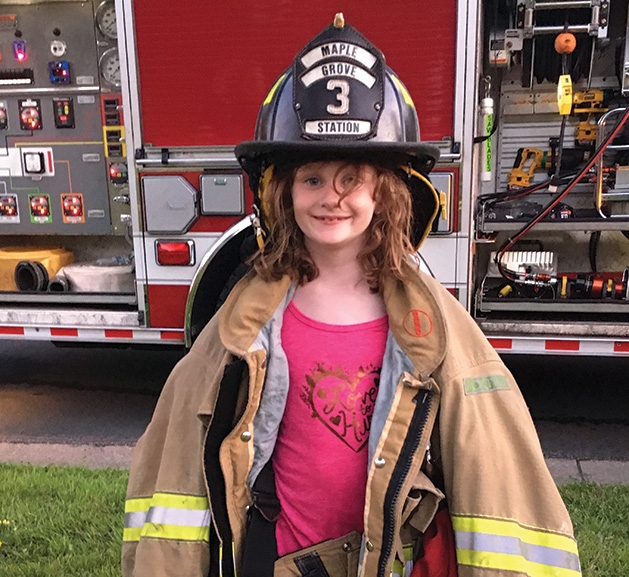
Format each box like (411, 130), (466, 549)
(306, 365), (380, 452)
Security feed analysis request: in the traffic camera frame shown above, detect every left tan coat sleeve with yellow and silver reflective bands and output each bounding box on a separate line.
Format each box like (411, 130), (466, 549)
(122, 330), (227, 577)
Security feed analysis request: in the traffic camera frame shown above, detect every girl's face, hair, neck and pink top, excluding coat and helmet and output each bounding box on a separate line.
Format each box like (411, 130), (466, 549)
(255, 161), (400, 556)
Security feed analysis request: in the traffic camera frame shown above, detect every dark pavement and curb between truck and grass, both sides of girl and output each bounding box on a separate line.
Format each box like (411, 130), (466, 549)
(0, 343), (629, 484)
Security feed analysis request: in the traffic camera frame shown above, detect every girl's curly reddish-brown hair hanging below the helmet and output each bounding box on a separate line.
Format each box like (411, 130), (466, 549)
(252, 161), (414, 292)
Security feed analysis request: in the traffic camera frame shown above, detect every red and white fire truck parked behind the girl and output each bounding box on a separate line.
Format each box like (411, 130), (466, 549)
(0, 0), (629, 356)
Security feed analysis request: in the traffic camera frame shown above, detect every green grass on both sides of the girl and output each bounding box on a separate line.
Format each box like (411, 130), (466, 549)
(0, 464), (629, 577)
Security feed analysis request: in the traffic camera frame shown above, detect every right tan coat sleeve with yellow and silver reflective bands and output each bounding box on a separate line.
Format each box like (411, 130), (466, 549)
(439, 319), (581, 577)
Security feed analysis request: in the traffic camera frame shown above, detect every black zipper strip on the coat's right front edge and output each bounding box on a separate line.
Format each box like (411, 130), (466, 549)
(378, 391), (433, 577)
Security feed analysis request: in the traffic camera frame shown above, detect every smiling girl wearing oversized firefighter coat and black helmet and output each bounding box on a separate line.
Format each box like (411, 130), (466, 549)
(123, 17), (580, 577)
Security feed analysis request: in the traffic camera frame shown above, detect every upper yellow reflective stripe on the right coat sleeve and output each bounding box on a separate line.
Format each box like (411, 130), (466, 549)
(452, 517), (578, 554)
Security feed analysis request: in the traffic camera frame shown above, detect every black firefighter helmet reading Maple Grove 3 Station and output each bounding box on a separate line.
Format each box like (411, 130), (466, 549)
(235, 14), (439, 245)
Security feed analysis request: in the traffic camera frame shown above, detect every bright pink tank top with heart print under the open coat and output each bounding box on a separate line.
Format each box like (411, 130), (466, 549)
(273, 303), (389, 556)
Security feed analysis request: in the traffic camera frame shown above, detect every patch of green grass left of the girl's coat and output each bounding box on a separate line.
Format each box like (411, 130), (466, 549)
(0, 464), (128, 577)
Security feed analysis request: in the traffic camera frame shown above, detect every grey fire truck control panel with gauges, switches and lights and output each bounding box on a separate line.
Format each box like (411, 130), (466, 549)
(0, 0), (130, 237)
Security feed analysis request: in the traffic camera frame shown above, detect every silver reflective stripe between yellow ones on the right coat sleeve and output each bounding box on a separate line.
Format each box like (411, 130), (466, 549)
(455, 531), (580, 571)
